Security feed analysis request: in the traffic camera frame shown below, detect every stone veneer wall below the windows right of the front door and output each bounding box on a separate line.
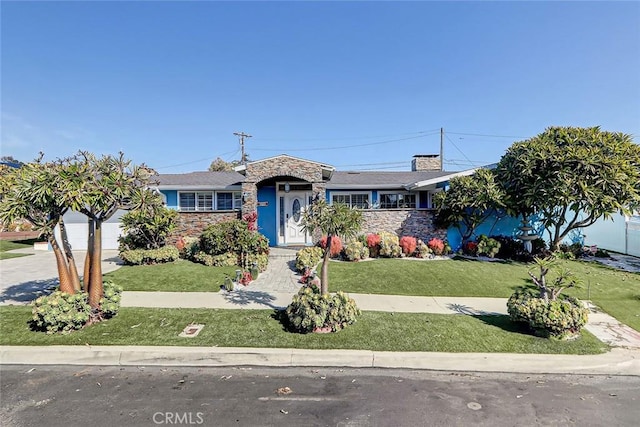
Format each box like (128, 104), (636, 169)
(362, 209), (447, 242)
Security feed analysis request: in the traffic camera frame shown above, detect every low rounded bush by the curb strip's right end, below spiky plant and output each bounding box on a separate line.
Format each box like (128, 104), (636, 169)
(507, 288), (589, 339)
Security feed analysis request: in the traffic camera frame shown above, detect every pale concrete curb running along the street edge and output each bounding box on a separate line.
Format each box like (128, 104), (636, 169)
(0, 346), (640, 376)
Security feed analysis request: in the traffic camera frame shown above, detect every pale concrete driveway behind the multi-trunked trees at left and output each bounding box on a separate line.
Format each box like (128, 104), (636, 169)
(0, 248), (122, 305)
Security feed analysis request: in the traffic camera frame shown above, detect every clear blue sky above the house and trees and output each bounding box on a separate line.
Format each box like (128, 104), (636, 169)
(1, 1), (640, 173)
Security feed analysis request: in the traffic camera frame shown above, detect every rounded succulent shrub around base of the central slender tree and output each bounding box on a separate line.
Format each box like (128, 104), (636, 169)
(285, 285), (360, 334)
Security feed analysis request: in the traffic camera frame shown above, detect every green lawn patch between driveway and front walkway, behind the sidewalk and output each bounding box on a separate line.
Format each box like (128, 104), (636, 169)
(104, 259), (239, 292)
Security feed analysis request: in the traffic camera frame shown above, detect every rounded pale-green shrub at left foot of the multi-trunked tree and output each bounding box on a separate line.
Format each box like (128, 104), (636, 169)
(31, 291), (91, 334)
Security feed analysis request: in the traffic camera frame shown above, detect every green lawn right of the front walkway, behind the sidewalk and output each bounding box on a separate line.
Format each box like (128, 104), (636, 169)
(329, 259), (640, 331)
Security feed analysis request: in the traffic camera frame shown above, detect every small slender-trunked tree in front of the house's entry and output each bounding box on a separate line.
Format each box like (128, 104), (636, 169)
(302, 200), (362, 294)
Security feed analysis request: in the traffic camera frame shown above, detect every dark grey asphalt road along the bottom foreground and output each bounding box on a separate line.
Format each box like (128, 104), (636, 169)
(0, 365), (640, 427)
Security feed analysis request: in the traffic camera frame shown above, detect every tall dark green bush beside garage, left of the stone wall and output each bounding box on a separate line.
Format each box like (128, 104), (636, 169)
(118, 205), (178, 252)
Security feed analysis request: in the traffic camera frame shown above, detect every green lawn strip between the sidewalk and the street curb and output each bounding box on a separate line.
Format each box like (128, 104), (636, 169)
(0, 306), (608, 354)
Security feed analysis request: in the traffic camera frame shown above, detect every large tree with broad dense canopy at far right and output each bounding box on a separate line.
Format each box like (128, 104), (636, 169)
(496, 127), (640, 250)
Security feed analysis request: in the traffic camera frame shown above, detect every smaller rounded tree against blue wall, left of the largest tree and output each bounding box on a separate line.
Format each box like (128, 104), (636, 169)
(434, 169), (505, 243)
